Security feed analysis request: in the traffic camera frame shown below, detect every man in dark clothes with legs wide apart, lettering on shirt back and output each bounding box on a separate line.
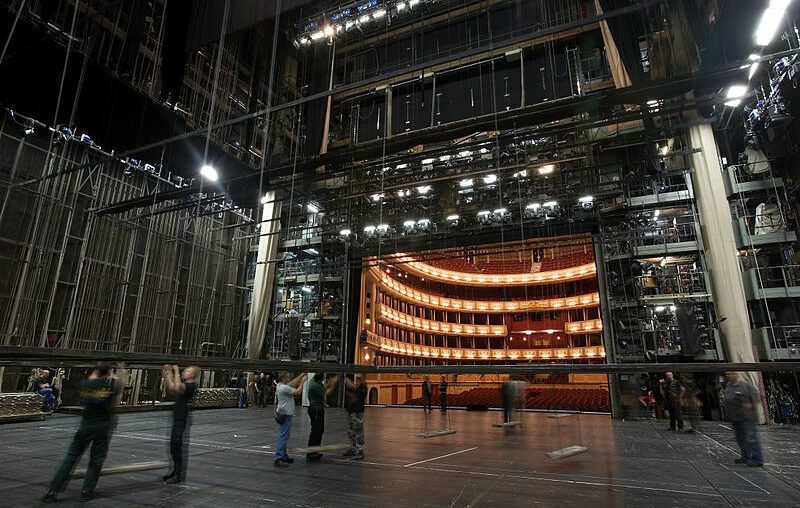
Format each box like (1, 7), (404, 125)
(42, 362), (118, 503)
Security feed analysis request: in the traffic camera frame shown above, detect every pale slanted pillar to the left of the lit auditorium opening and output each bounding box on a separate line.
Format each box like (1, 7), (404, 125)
(247, 191), (281, 358)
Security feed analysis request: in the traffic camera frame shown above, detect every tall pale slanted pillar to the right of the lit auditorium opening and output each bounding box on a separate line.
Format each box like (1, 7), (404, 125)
(688, 123), (764, 423)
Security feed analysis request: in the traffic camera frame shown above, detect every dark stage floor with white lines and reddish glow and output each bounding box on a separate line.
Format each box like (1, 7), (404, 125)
(0, 408), (800, 508)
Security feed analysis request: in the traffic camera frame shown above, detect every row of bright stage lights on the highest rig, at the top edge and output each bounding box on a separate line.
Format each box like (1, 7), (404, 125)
(295, 0), (421, 47)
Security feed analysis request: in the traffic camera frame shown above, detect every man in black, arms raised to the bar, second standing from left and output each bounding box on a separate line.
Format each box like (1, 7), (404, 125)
(163, 365), (198, 484)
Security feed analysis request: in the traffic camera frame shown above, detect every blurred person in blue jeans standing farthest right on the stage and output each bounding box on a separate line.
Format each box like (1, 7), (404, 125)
(725, 372), (764, 467)
